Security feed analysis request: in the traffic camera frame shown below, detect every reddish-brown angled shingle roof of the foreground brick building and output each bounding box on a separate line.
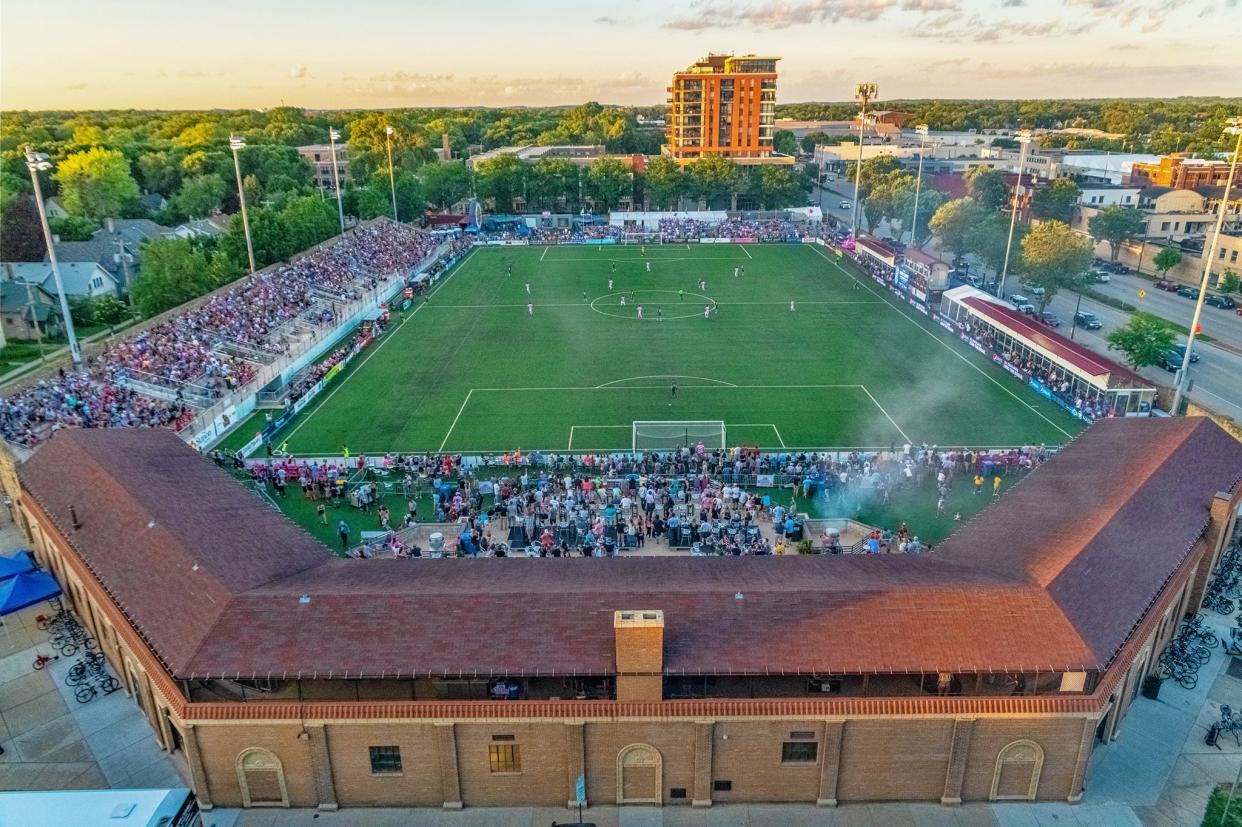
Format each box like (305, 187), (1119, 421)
(20, 418), (1242, 678)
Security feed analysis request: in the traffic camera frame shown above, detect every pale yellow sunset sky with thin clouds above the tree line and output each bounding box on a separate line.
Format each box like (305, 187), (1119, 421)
(0, 0), (1242, 109)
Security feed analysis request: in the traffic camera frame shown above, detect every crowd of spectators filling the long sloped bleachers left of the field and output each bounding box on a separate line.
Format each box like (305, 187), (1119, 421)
(0, 221), (441, 446)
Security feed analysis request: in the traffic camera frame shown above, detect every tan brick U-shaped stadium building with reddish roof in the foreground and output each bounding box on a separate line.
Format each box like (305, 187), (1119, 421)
(0, 417), (1242, 810)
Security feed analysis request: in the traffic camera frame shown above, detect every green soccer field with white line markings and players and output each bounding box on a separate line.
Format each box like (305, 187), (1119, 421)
(264, 245), (1082, 454)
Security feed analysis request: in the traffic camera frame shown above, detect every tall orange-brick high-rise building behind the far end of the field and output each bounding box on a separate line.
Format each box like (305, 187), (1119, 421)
(663, 55), (794, 164)
